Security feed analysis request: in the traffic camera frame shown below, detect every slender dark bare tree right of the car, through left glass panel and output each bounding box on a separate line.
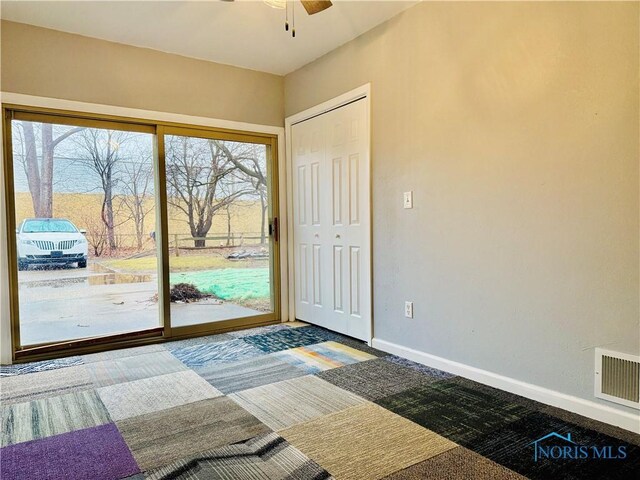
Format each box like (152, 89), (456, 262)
(75, 128), (130, 251)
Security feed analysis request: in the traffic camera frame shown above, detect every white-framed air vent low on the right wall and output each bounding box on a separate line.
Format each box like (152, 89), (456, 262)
(595, 348), (640, 409)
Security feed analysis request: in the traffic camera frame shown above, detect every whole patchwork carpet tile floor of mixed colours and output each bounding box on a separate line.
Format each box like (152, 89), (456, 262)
(0, 322), (640, 480)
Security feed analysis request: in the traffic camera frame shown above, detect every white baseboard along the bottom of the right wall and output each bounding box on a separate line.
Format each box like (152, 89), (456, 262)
(371, 338), (640, 433)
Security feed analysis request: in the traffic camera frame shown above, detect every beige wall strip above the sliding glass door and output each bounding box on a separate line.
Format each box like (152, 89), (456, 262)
(1, 21), (284, 126)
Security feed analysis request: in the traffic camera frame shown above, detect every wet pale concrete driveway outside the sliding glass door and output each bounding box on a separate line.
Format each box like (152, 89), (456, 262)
(19, 264), (262, 345)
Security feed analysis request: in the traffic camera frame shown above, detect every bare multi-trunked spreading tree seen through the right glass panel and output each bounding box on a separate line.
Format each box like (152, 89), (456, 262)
(166, 137), (251, 247)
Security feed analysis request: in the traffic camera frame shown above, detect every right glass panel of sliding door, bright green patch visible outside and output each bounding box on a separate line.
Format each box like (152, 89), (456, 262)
(164, 135), (276, 328)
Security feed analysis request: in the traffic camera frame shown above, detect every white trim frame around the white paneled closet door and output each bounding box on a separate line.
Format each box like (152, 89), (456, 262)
(284, 83), (373, 345)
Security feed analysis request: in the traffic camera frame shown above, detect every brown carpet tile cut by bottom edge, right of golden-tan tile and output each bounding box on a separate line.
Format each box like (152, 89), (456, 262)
(384, 447), (525, 480)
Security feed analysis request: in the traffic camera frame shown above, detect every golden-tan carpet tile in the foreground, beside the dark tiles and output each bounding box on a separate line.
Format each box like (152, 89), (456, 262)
(280, 402), (456, 480)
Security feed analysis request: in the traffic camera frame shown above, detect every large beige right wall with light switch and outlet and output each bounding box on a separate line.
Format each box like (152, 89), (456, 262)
(285, 2), (640, 411)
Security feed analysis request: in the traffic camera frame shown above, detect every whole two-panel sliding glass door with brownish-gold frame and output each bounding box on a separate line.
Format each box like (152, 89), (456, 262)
(4, 108), (279, 356)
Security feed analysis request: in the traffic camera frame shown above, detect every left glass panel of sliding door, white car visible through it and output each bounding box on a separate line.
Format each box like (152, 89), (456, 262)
(11, 117), (160, 347)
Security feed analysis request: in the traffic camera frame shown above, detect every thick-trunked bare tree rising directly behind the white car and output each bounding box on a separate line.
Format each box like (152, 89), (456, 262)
(13, 121), (83, 218)
